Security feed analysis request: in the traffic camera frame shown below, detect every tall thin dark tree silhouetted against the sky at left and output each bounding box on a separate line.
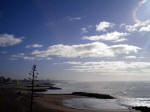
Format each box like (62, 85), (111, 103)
(29, 65), (38, 112)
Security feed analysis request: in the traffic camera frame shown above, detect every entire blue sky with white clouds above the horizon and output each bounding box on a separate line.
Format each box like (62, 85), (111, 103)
(0, 0), (150, 81)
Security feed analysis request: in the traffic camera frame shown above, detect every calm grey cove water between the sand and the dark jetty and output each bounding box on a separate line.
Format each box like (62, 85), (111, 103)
(63, 98), (128, 110)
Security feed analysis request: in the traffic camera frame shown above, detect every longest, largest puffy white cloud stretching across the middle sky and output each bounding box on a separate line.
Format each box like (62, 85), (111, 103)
(32, 42), (140, 58)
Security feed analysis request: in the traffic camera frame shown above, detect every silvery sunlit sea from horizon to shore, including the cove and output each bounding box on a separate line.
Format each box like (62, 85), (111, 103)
(45, 81), (150, 109)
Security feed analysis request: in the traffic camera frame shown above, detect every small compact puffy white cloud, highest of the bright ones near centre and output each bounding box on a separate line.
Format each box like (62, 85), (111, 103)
(96, 21), (114, 31)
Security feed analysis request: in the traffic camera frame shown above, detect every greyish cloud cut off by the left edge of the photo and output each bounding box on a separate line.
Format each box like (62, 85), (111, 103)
(0, 34), (23, 47)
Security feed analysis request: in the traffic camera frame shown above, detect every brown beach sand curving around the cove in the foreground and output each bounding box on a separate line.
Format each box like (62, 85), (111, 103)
(35, 94), (129, 112)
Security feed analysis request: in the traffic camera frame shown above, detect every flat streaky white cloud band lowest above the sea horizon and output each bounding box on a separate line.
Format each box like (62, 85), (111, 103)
(66, 61), (150, 73)
